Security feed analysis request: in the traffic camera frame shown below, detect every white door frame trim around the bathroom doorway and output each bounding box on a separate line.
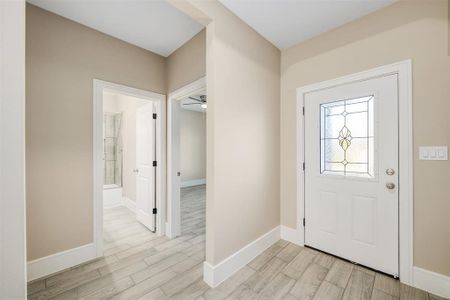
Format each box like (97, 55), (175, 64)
(92, 79), (166, 257)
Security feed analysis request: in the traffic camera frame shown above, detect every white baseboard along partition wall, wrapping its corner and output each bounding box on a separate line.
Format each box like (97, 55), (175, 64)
(203, 226), (280, 288)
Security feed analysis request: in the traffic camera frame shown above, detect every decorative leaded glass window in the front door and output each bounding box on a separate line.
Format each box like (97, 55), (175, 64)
(320, 95), (375, 178)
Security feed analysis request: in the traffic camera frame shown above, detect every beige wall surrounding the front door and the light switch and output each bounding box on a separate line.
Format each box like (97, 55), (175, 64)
(280, 0), (450, 275)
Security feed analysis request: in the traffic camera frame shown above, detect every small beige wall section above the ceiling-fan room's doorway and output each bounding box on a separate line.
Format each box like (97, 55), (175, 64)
(167, 29), (206, 93)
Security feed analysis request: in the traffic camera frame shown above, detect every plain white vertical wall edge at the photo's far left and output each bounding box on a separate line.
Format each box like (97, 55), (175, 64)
(0, 0), (27, 299)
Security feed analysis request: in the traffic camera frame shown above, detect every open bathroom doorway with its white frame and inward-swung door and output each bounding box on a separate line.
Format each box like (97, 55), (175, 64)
(94, 80), (164, 257)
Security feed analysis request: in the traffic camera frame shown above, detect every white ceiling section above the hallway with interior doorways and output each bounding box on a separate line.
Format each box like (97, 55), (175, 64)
(28, 0), (202, 56)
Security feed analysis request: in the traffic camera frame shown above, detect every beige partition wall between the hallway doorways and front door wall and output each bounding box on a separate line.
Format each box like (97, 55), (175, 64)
(172, 0), (280, 265)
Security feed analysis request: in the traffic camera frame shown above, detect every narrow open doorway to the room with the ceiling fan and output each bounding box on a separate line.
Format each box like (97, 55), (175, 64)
(166, 78), (207, 238)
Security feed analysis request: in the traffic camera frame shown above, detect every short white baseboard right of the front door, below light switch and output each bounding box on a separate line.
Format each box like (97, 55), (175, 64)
(413, 267), (450, 298)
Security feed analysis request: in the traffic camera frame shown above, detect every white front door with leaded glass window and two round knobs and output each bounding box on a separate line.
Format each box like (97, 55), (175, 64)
(304, 75), (399, 276)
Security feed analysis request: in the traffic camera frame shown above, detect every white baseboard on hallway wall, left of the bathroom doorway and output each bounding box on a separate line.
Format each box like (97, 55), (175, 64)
(27, 243), (97, 281)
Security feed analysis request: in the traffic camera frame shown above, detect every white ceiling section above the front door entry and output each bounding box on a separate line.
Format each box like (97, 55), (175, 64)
(219, 0), (396, 49)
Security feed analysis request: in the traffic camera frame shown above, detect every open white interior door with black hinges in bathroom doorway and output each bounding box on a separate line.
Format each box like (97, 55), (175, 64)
(135, 103), (156, 231)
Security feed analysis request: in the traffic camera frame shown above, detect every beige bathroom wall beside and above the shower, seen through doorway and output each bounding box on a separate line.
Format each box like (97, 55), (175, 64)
(103, 93), (149, 201)
